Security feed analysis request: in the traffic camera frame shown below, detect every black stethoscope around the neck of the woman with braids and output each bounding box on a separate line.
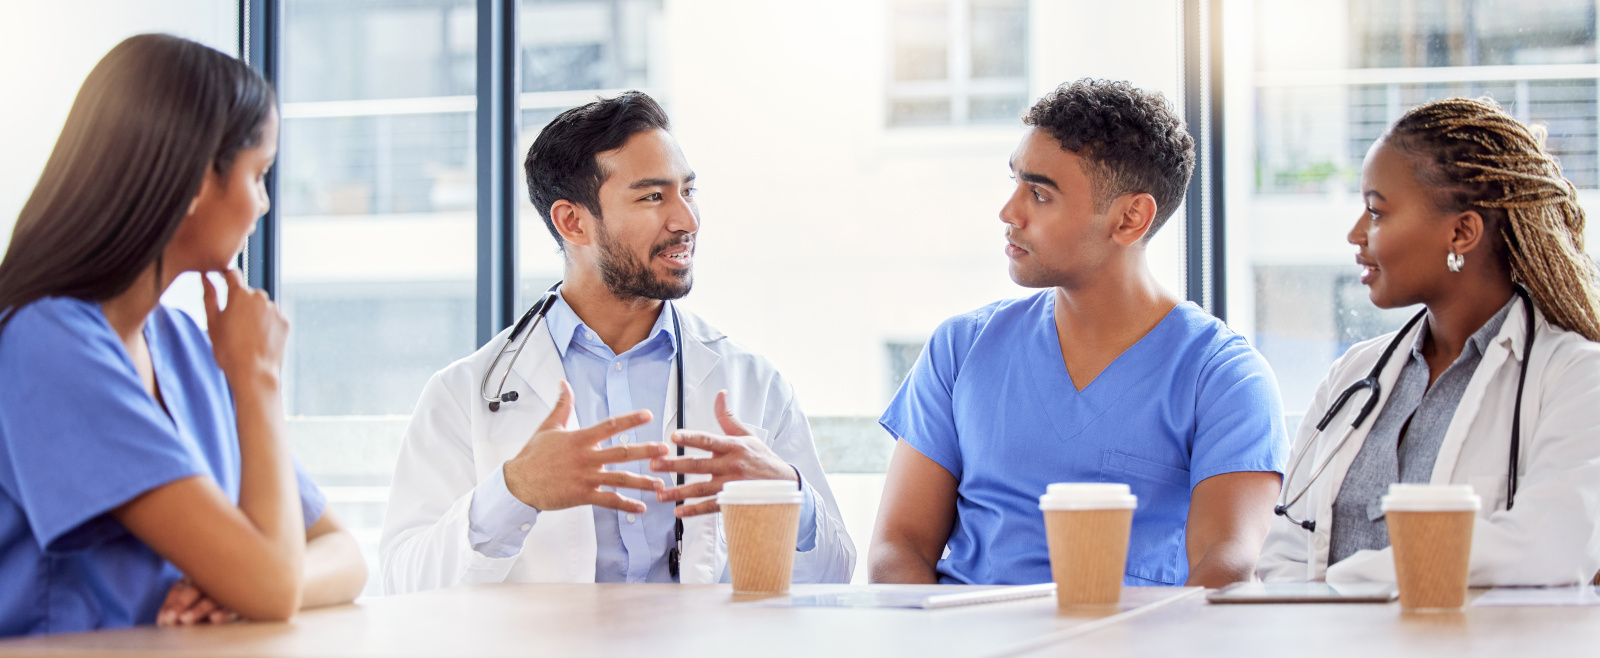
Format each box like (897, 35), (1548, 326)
(1272, 283), (1534, 532)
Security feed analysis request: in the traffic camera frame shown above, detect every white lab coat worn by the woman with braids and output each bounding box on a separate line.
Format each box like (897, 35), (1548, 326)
(1258, 301), (1600, 586)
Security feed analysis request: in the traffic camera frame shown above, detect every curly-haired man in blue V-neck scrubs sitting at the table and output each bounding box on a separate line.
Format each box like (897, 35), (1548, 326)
(869, 80), (1288, 588)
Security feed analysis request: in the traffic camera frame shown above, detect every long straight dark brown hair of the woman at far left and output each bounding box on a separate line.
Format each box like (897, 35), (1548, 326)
(0, 34), (277, 331)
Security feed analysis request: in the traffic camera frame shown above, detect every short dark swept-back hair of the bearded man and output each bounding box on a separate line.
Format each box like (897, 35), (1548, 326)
(522, 91), (672, 250)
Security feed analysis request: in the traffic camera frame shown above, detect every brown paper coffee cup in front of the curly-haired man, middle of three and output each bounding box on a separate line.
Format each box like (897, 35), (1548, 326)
(1038, 482), (1139, 608)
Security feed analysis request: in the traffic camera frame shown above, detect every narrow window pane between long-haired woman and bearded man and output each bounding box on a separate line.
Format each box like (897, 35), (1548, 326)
(274, 0), (477, 592)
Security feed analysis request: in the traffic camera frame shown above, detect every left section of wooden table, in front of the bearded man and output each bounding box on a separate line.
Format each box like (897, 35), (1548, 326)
(0, 584), (1200, 658)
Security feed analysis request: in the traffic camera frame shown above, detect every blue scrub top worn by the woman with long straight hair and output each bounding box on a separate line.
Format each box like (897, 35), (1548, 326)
(0, 298), (325, 636)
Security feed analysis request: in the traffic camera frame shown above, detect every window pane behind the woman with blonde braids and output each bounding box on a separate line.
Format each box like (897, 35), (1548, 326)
(1227, 0), (1600, 413)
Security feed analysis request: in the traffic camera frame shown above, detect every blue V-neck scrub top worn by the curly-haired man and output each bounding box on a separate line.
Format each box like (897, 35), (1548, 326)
(880, 290), (1288, 586)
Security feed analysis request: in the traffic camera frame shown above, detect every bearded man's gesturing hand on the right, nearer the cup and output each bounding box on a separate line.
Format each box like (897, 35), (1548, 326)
(650, 391), (798, 517)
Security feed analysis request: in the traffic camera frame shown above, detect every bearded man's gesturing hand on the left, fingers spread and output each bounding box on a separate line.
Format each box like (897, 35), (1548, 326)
(506, 381), (669, 514)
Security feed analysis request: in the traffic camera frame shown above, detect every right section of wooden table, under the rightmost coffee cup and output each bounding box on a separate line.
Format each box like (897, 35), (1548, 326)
(1022, 592), (1600, 658)
